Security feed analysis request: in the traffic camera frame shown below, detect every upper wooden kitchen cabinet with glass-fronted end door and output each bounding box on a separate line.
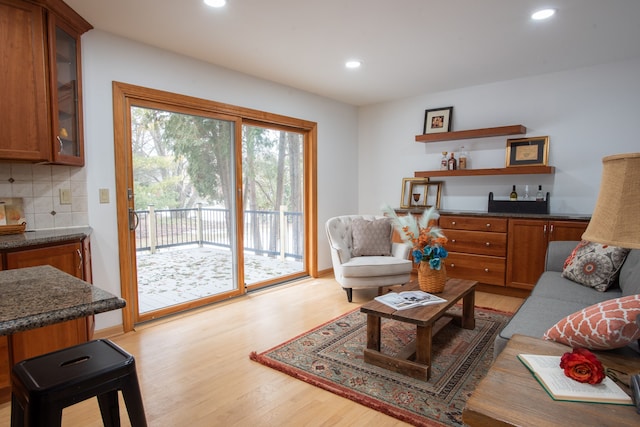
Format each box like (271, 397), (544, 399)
(0, 0), (93, 166)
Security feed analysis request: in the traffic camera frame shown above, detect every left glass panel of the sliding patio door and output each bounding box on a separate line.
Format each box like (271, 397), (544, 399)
(130, 106), (239, 321)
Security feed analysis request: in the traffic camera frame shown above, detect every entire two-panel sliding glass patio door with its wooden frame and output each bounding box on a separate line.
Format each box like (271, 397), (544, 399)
(113, 82), (317, 332)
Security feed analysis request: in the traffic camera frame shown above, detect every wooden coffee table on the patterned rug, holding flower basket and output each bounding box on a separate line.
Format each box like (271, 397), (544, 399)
(360, 279), (478, 380)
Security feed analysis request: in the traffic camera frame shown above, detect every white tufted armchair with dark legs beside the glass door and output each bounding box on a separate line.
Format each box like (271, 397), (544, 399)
(325, 215), (412, 302)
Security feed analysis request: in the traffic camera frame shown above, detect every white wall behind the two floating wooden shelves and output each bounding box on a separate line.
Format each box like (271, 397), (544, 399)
(358, 60), (640, 214)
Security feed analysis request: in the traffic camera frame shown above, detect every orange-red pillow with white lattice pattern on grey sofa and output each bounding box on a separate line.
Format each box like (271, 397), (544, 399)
(543, 295), (640, 350)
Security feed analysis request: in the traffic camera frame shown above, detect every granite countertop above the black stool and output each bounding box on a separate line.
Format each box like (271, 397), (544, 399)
(0, 265), (126, 335)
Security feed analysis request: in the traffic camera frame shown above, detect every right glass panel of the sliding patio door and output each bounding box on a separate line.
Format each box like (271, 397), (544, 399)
(242, 124), (305, 289)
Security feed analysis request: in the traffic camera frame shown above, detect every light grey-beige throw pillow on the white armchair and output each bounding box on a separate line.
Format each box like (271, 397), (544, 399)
(351, 218), (393, 256)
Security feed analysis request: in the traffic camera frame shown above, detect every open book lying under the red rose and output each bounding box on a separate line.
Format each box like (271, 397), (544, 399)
(518, 354), (633, 405)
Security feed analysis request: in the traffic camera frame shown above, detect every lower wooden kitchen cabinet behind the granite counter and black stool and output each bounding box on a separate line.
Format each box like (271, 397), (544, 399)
(0, 237), (94, 401)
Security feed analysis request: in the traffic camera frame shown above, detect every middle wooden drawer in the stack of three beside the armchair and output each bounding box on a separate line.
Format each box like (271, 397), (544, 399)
(443, 229), (507, 257)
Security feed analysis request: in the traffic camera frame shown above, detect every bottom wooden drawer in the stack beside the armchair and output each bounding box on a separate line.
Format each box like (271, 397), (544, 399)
(445, 252), (506, 286)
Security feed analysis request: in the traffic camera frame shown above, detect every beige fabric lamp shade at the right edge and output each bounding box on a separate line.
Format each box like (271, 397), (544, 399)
(582, 153), (640, 249)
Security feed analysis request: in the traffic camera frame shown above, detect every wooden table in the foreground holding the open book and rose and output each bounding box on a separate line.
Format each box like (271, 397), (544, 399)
(462, 335), (640, 427)
